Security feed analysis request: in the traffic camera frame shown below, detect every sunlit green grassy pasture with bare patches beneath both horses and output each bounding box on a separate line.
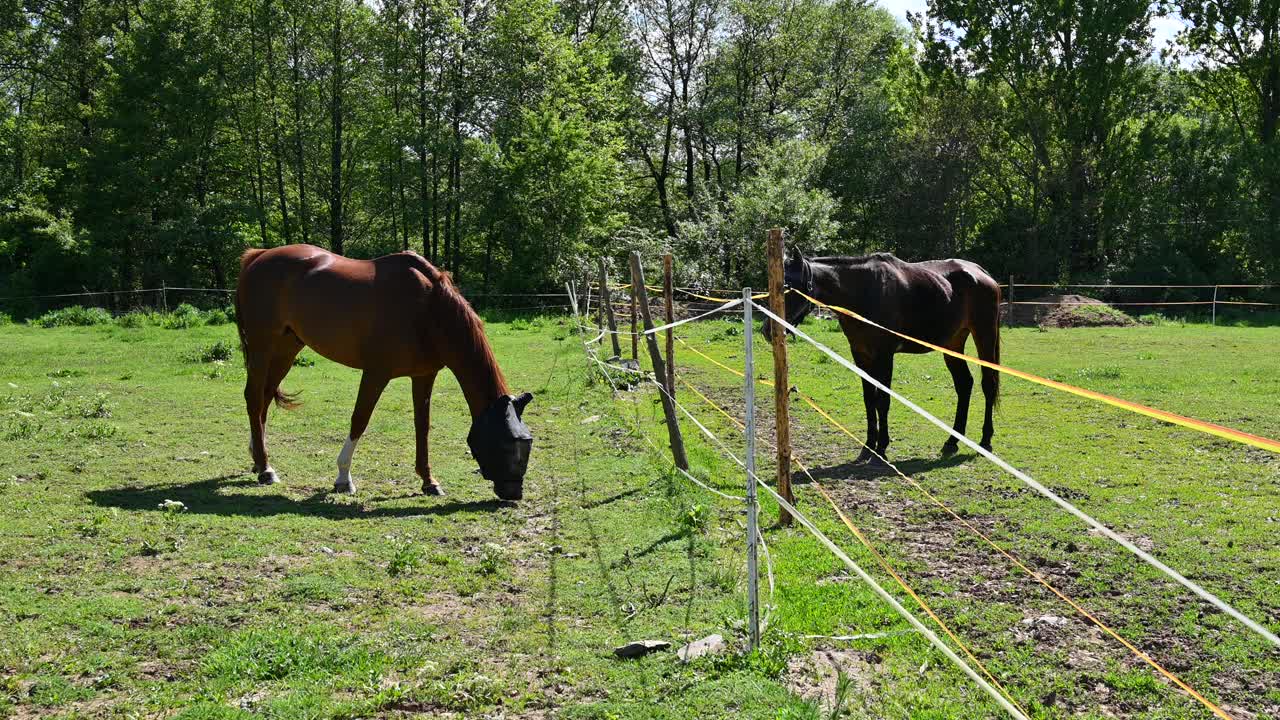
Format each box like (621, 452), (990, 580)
(0, 310), (1280, 719)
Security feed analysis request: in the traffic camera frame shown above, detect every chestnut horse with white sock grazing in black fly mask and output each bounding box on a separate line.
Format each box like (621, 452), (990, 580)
(236, 245), (534, 500)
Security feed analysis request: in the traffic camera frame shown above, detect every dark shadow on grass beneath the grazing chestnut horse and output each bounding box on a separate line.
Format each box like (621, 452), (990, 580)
(84, 474), (509, 520)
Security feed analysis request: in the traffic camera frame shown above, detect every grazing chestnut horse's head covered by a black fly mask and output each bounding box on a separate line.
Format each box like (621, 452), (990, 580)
(467, 392), (534, 500)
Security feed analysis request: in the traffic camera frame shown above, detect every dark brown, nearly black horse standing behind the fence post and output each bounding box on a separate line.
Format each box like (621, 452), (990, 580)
(764, 251), (1000, 462)
